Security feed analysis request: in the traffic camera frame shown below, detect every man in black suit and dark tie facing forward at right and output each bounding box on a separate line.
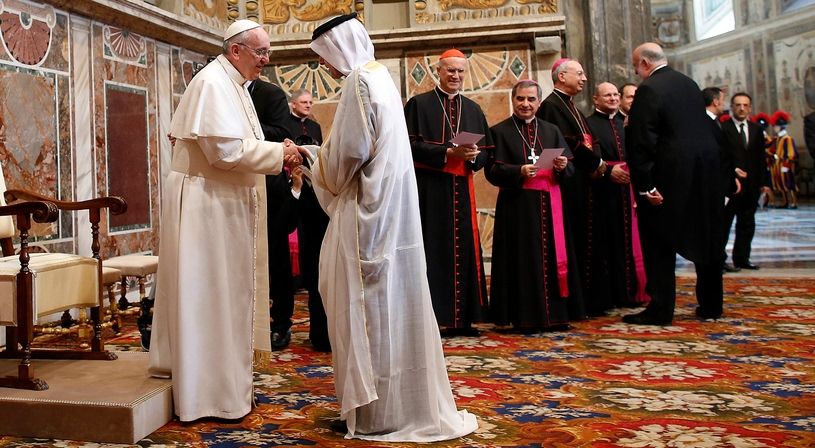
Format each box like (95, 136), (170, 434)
(722, 92), (765, 269)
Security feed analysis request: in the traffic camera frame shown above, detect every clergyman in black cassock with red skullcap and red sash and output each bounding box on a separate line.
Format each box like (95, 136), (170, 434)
(405, 50), (492, 334)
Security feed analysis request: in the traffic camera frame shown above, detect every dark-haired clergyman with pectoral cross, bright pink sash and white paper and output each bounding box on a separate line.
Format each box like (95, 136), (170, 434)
(486, 81), (577, 332)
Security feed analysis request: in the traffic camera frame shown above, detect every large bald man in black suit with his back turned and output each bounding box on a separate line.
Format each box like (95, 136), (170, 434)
(623, 42), (724, 325)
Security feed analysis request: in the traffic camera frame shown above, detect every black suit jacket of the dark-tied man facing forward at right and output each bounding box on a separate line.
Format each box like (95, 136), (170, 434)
(722, 120), (766, 202)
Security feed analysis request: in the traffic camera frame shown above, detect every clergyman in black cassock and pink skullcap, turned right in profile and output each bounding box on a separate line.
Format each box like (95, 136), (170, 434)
(537, 59), (608, 319)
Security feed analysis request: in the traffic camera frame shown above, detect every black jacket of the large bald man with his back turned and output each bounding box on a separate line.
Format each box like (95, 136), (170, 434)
(626, 67), (724, 263)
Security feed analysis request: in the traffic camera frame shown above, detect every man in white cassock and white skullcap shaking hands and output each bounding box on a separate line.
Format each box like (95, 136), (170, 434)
(149, 20), (300, 421)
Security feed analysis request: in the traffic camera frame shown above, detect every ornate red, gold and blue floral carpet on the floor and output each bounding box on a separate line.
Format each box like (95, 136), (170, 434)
(0, 278), (815, 448)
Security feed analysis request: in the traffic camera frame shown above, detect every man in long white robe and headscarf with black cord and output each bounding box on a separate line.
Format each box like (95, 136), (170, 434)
(311, 14), (478, 442)
